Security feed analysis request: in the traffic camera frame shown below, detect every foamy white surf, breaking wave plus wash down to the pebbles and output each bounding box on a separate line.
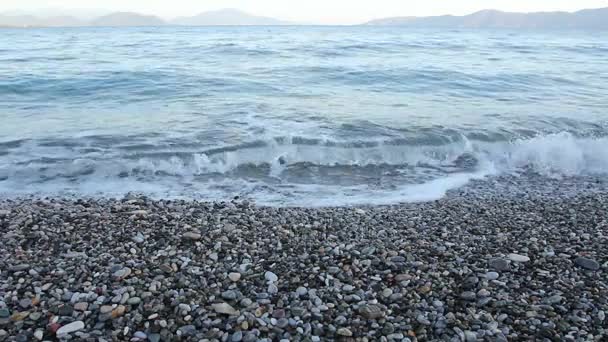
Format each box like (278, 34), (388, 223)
(0, 132), (608, 206)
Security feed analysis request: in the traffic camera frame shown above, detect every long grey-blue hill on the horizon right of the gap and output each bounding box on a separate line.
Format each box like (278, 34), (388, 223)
(366, 7), (608, 29)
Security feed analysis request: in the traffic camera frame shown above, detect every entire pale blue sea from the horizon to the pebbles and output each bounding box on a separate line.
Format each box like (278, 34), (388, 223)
(0, 26), (608, 207)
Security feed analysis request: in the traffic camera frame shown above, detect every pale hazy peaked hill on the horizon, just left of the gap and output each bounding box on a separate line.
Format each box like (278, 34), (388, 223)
(171, 9), (289, 26)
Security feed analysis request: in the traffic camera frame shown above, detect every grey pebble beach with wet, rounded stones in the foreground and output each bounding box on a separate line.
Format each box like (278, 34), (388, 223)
(0, 184), (608, 341)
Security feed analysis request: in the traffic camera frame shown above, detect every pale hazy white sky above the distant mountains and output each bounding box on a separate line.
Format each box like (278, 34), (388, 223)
(0, 0), (608, 24)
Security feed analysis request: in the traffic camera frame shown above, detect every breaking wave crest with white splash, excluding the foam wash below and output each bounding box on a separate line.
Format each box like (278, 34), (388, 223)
(3, 132), (608, 177)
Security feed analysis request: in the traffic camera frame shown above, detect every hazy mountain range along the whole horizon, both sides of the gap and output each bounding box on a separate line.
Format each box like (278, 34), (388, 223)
(0, 7), (608, 29)
